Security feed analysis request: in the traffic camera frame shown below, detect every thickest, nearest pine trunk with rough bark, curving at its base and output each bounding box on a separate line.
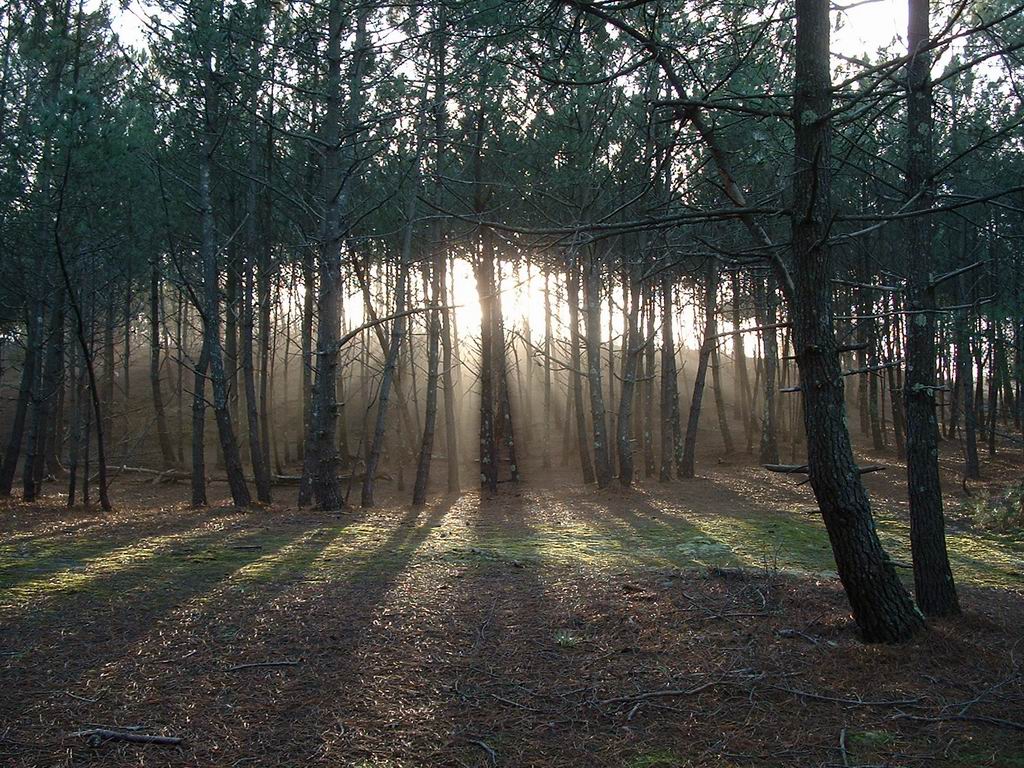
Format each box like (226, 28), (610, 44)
(791, 0), (923, 642)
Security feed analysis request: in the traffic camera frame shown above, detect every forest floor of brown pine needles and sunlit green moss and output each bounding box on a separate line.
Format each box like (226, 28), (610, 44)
(0, 450), (1024, 768)
